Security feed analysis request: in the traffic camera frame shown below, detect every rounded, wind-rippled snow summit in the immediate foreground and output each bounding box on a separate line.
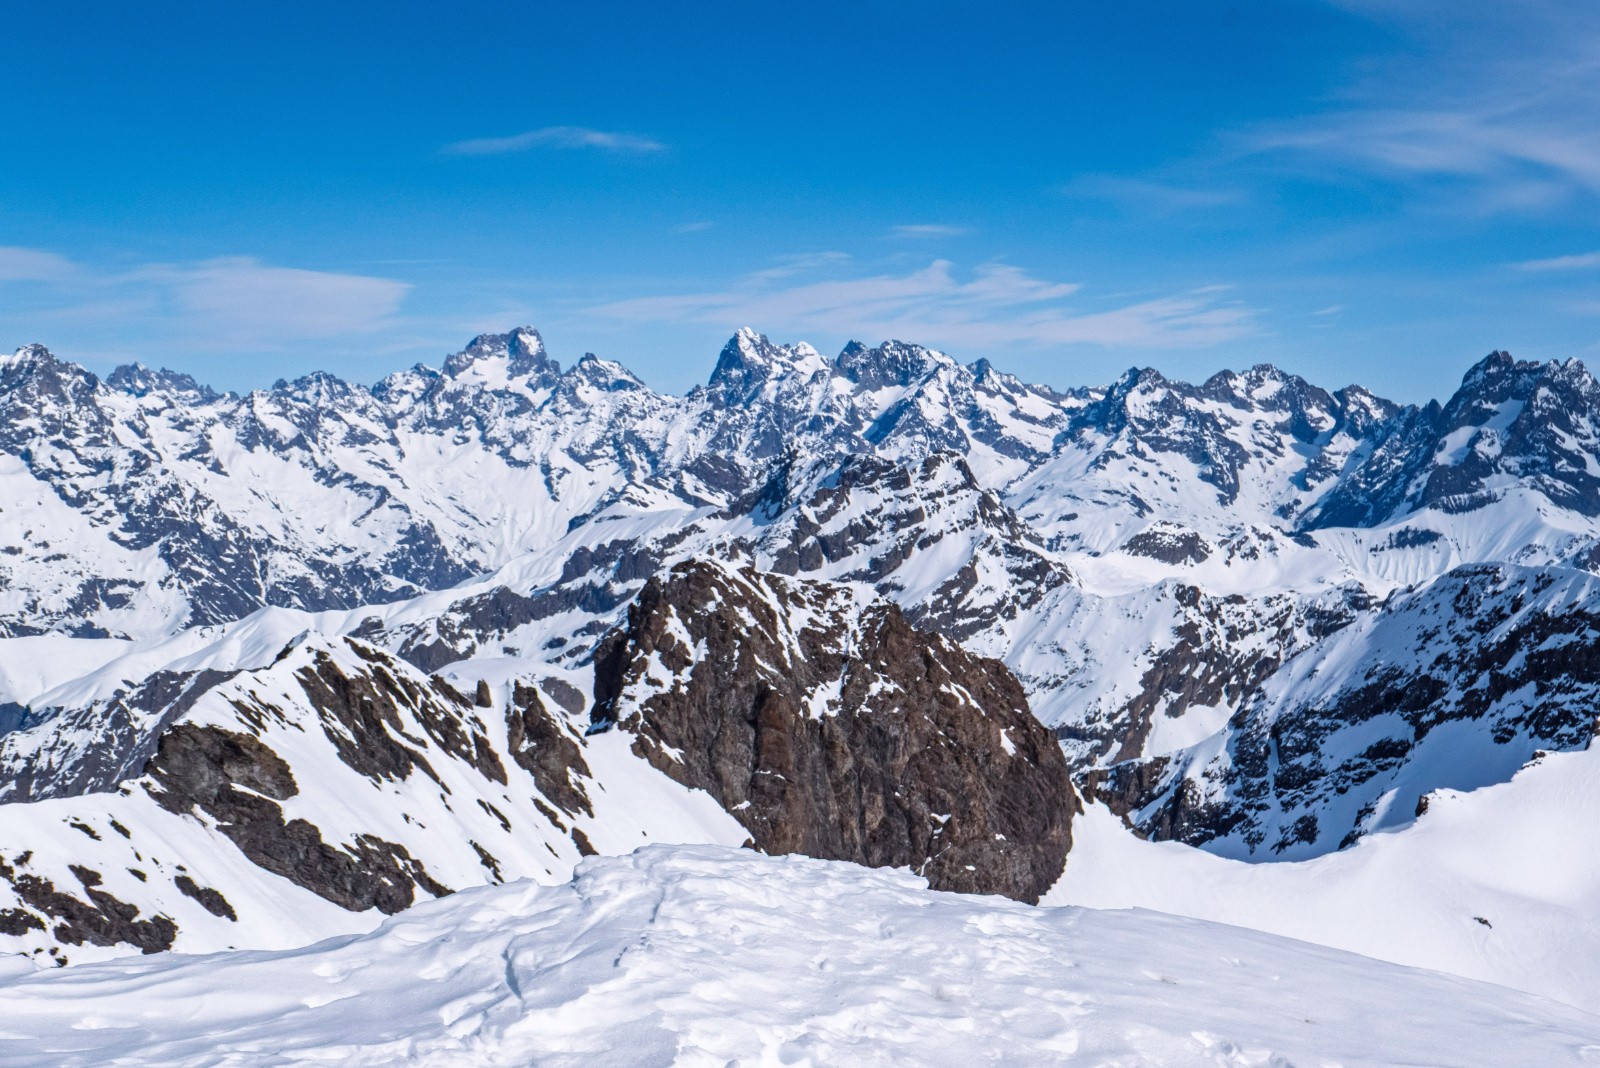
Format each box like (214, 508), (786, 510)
(0, 846), (1600, 1068)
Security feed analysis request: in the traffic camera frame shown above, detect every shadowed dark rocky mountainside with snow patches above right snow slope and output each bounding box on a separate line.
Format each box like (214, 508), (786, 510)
(1082, 564), (1600, 859)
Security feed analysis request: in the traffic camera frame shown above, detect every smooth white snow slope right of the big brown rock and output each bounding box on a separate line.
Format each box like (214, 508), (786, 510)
(1045, 738), (1600, 1016)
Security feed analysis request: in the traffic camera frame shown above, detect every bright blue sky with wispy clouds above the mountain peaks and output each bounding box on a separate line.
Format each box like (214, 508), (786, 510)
(0, 0), (1600, 400)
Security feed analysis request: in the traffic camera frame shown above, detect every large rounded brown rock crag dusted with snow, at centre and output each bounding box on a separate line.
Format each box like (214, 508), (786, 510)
(592, 561), (1077, 902)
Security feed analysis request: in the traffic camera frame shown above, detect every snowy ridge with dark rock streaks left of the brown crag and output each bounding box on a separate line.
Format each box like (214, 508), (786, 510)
(0, 633), (746, 966)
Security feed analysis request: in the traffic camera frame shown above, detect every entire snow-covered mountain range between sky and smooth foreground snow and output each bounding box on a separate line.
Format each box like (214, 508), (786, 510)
(0, 328), (1600, 1023)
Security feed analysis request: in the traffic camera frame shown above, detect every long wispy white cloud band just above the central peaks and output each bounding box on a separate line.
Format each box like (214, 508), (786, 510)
(592, 259), (1254, 349)
